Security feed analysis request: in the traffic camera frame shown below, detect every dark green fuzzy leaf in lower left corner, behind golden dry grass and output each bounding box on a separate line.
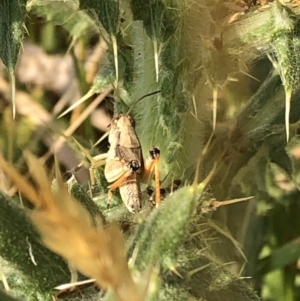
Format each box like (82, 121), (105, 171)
(0, 193), (69, 300)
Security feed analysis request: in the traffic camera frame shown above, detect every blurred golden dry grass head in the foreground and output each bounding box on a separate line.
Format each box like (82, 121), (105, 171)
(0, 153), (142, 301)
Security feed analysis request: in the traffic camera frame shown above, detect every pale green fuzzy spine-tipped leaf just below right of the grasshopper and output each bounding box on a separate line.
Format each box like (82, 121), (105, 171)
(129, 186), (202, 270)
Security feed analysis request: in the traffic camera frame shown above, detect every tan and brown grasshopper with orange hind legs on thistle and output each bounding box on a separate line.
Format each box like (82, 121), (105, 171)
(91, 91), (160, 213)
